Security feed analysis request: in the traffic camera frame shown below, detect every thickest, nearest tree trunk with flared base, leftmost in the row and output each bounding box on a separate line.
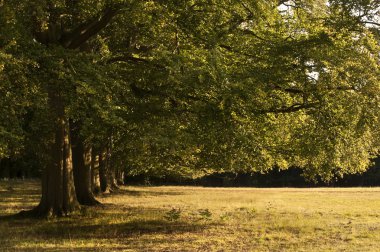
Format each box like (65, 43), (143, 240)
(32, 92), (79, 216)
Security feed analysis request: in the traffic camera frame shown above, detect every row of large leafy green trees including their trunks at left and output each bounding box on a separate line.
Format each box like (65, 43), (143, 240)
(0, 0), (380, 215)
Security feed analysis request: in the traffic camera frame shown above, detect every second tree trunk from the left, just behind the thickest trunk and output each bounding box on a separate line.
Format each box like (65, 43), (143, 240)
(71, 124), (100, 206)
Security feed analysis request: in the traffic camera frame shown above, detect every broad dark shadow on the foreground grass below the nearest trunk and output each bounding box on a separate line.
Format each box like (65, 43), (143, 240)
(0, 206), (210, 251)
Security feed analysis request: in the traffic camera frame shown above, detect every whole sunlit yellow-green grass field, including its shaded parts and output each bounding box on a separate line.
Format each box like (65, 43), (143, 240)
(0, 181), (380, 251)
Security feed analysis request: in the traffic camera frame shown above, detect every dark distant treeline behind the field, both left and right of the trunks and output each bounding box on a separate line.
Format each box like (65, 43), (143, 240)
(0, 158), (380, 187)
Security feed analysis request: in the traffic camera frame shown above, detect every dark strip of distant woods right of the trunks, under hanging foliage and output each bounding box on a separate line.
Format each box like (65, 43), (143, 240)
(125, 158), (380, 187)
